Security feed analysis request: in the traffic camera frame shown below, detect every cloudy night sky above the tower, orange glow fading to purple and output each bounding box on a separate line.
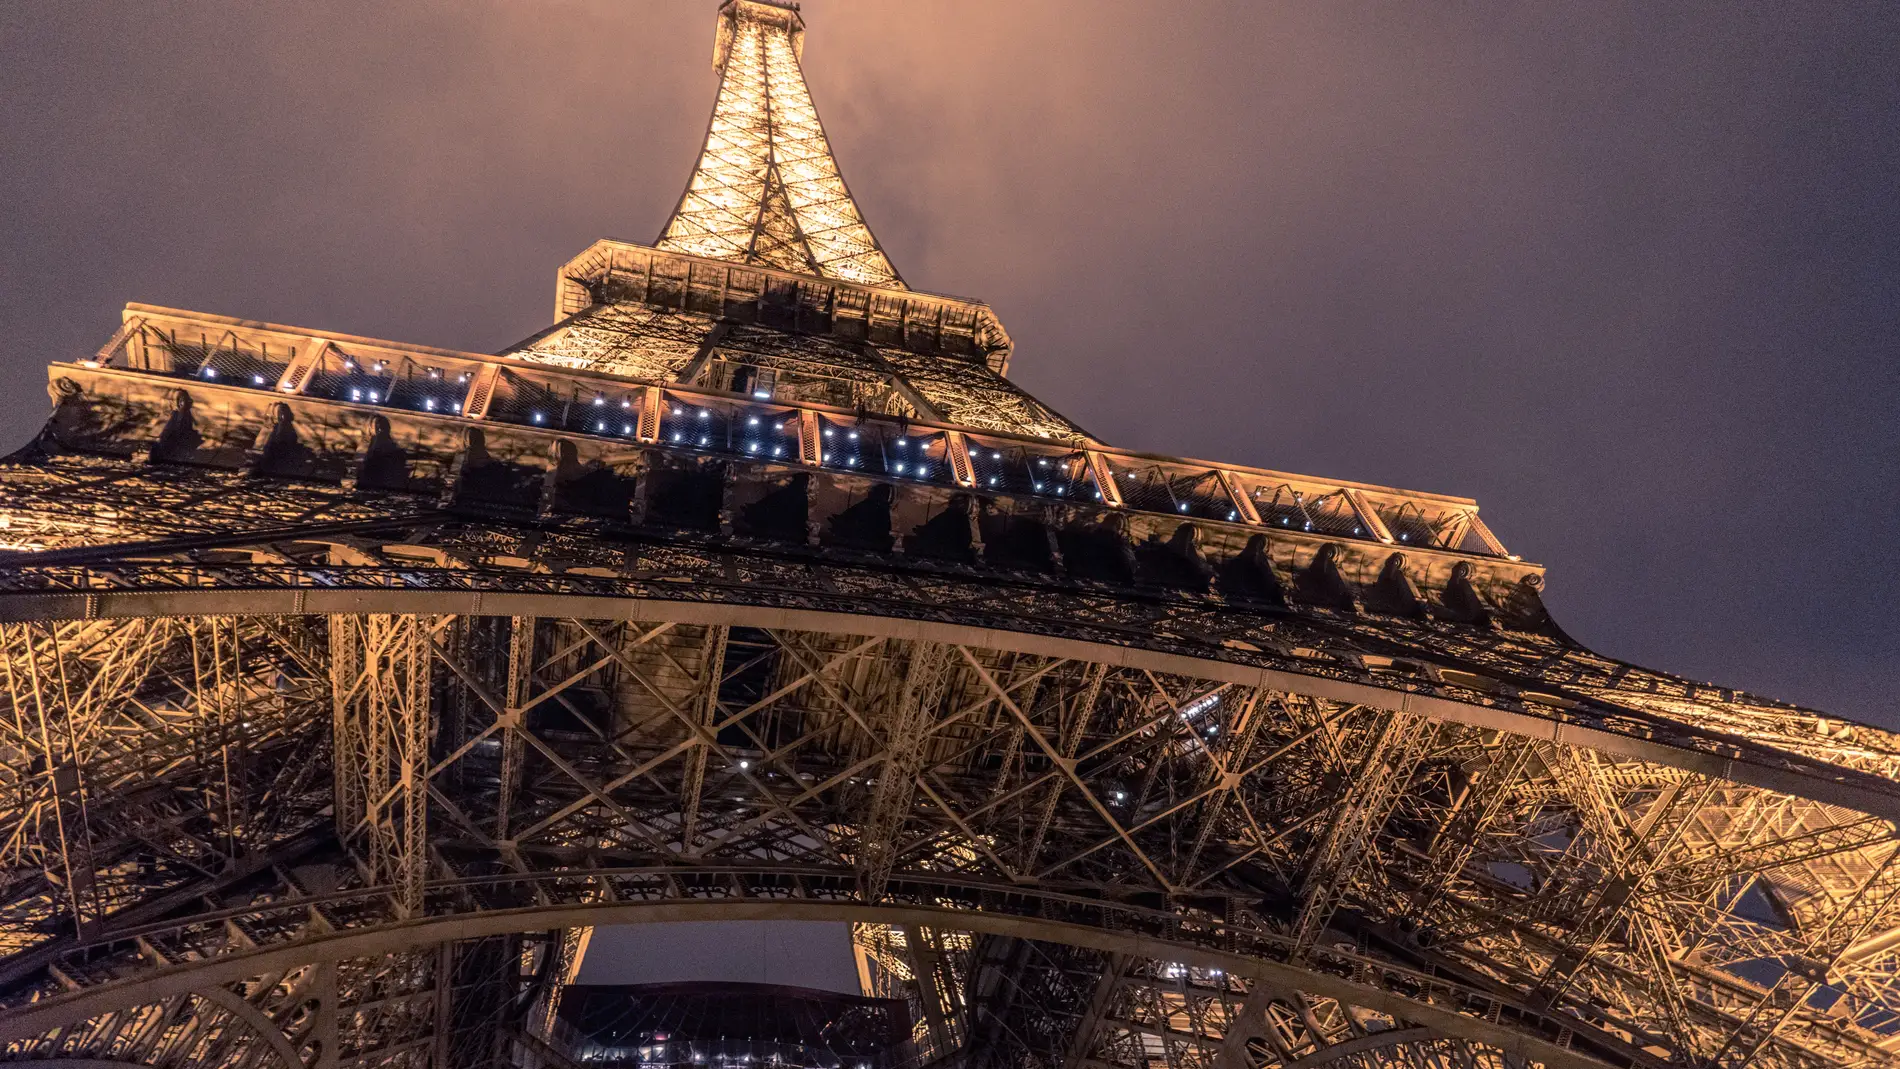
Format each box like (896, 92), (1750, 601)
(0, 0), (1900, 727)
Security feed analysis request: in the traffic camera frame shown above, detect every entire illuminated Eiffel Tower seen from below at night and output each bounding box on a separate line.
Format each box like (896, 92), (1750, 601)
(0, 0), (1900, 1069)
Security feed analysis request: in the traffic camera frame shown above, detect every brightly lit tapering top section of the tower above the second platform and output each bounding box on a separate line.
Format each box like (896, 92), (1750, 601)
(656, 0), (904, 289)
